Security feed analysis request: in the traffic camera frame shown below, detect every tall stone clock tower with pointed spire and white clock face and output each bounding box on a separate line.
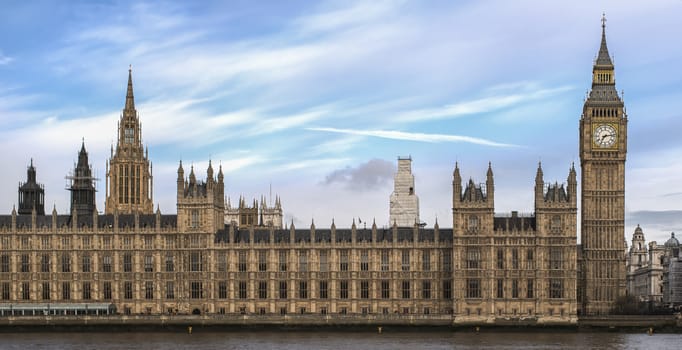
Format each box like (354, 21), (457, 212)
(578, 17), (627, 315)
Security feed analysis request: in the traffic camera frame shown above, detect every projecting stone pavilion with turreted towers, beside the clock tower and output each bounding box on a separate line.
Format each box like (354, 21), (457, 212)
(452, 165), (577, 323)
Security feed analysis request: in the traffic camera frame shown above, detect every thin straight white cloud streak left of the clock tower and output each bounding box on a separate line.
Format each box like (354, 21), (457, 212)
(306, 128), (519, 147)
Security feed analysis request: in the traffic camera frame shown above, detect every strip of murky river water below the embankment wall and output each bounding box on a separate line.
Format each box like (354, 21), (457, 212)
(0, 331), (682, 350)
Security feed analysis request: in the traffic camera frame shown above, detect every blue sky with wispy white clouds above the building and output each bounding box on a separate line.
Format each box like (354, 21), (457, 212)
(0, 0), (682, 243)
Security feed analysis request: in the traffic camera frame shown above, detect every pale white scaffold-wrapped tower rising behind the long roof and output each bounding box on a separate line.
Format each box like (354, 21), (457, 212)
(389, 157), (421, 227)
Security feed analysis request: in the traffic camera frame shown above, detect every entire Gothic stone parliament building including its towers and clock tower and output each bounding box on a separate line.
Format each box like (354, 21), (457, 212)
(0, 17), (627, 325)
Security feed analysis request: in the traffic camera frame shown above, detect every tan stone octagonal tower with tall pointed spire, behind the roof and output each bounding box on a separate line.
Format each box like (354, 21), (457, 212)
(104, 69), (154, 214)
